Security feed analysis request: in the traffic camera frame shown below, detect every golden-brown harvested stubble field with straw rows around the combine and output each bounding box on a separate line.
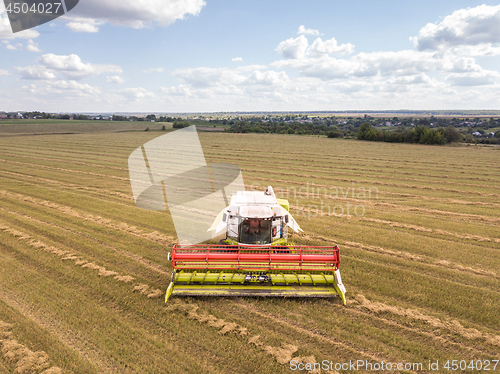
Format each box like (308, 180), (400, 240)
(0, 125), (500, 374)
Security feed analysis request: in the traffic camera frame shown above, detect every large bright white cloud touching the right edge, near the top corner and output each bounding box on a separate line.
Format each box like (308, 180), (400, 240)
(410, 5), (500, 51)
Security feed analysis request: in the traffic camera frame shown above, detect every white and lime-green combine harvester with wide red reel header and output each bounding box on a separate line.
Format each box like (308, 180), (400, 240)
(165, 186), (346, 305)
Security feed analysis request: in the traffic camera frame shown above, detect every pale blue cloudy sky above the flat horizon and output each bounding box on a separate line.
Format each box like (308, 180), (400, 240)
(0, 0), (500, 112)
